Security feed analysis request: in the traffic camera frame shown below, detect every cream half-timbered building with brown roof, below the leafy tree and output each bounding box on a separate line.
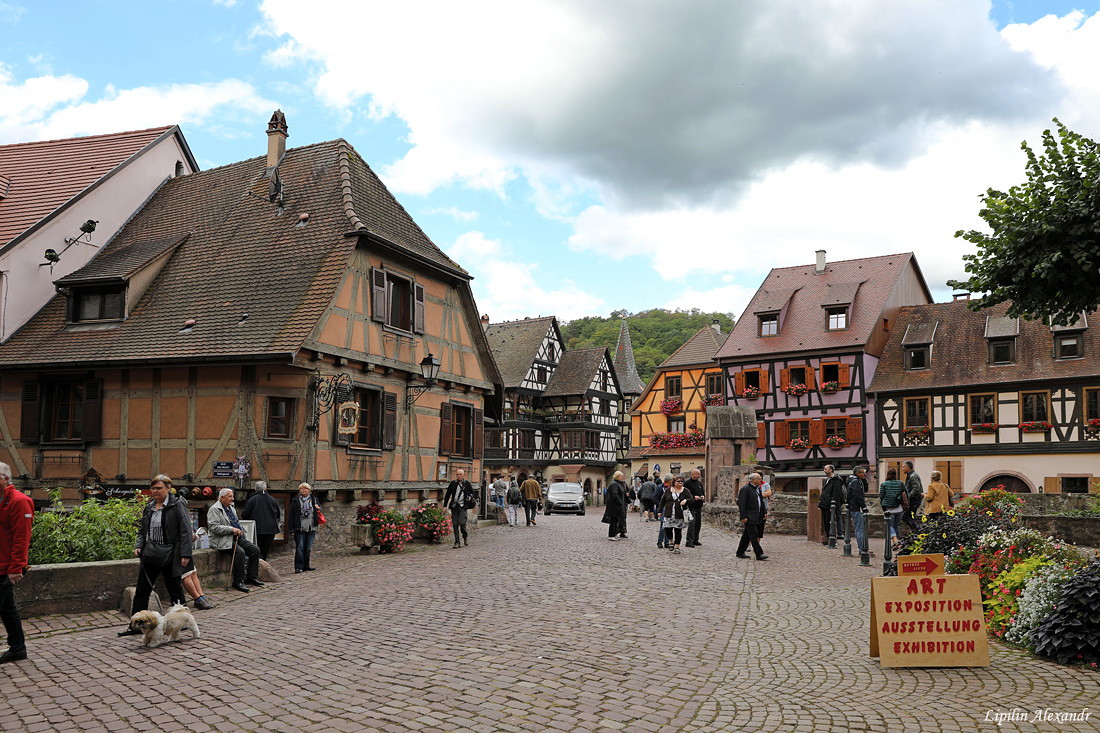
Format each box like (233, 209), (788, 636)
(870, 296), (1100, 493)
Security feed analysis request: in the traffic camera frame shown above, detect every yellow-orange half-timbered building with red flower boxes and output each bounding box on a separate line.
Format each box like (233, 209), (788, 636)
(627, 321), (726, 477)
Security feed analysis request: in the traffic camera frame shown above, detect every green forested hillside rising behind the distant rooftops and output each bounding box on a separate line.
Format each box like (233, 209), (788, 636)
(561, 308), (734, 382)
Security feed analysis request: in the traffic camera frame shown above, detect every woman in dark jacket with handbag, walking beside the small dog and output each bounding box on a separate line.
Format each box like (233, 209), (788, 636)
(119, 477), (191, 636)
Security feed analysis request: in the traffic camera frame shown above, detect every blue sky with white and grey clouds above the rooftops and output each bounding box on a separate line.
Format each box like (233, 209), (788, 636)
(0, 0), (1100, 321)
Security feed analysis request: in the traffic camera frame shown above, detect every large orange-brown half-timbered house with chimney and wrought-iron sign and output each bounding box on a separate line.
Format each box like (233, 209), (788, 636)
(0, 112), (499, 545)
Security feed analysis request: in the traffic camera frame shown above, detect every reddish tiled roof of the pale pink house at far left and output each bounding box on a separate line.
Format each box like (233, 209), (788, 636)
(0, 125), (177, 247)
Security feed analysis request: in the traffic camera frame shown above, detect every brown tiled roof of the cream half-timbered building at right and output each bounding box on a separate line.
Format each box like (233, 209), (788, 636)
(869, 303), (1100, 392)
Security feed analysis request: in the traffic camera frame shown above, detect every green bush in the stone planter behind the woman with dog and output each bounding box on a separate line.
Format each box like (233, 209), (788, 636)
(30, 489), (145, 565)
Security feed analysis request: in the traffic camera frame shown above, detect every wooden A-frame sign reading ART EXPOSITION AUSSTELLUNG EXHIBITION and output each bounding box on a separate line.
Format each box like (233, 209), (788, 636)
(870, 566), (989, 667)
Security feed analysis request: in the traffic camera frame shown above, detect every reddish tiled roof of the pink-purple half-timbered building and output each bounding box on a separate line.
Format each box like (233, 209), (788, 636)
(715, 253), (931, 359)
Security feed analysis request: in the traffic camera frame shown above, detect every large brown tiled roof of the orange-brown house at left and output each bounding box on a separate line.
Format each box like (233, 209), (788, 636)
(0, 140), (457, 365)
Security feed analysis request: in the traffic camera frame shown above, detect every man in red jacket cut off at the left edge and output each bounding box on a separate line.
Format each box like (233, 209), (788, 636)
(0, 463), (34, 664)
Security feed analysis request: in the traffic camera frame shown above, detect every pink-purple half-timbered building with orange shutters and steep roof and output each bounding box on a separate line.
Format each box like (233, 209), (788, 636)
(715, 250), (932, 491)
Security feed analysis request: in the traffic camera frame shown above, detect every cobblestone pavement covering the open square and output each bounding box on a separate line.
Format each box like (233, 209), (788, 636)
(0, 514), (1100, 733)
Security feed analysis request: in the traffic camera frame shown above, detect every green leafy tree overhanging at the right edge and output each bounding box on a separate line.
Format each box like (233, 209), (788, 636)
(947, 118), (1100, 326)
